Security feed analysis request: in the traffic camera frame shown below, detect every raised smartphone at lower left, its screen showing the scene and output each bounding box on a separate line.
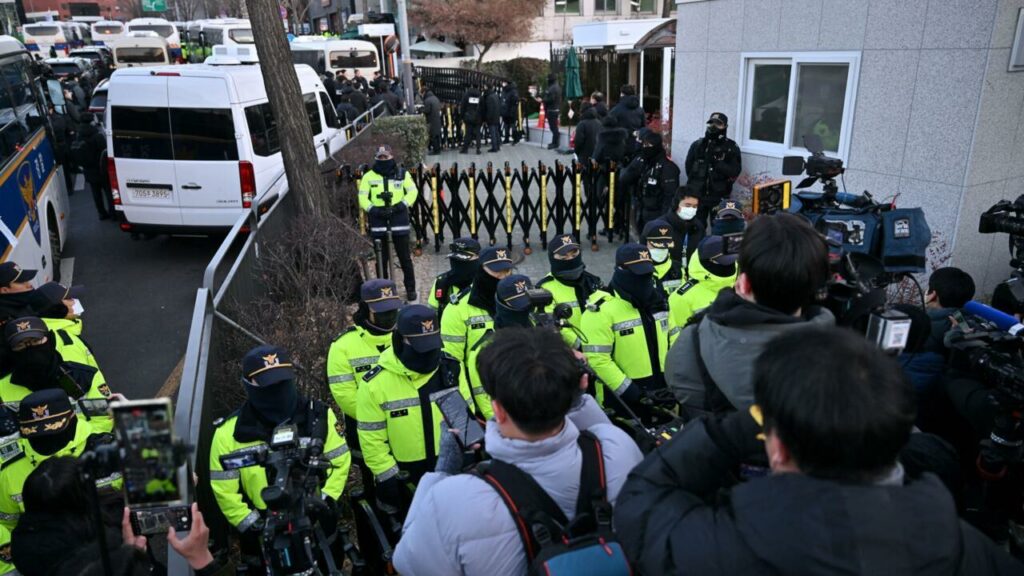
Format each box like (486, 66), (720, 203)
(111, 399), (183, 505)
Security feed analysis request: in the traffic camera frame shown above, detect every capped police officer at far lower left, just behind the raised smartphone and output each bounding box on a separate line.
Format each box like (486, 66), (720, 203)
(0, 388), (121, 574)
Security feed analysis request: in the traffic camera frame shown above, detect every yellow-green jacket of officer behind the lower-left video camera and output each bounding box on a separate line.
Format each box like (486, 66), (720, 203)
(210, 400), (352, 532)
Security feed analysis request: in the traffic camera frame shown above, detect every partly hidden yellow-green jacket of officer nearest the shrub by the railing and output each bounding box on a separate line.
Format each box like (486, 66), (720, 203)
(327, 325), (391, 420)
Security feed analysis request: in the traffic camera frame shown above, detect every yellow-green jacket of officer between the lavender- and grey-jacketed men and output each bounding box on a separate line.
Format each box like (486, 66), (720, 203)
(583, 290), (669, 401)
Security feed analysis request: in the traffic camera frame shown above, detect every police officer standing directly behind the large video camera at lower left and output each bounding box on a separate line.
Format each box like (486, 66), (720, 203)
(210, 345), (352, 557)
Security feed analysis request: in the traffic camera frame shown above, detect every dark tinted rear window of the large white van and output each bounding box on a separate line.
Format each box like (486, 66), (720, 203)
(111, 106), (239, 162)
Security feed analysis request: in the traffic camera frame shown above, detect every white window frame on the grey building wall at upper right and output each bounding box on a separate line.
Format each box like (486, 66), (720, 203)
(735, 52), (860, 161)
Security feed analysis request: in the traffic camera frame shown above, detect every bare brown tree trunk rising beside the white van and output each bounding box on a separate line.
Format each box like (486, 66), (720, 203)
(246, 0), (331, 216)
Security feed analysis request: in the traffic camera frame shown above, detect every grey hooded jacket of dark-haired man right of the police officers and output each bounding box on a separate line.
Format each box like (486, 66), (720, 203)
(665, 288), (836, 410)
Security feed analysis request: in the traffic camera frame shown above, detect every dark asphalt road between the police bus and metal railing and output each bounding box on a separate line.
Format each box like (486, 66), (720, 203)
(62, 176), (221, 398)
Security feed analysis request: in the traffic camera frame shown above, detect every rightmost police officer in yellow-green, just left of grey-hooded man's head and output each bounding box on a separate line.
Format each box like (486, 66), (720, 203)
(669, 236), (739, 345)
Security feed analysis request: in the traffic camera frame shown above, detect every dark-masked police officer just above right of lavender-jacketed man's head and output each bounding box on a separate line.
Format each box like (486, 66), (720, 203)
(537, 234), (603, 349)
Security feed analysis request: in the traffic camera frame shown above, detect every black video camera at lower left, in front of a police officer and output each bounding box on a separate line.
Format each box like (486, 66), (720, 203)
(220, 418), (341, 574)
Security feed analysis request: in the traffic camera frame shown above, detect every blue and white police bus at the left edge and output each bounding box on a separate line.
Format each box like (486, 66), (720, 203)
(0, 36), (69, 284)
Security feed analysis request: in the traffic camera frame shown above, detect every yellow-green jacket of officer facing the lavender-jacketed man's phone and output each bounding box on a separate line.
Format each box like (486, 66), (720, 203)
(356, 348), (459, 483)
